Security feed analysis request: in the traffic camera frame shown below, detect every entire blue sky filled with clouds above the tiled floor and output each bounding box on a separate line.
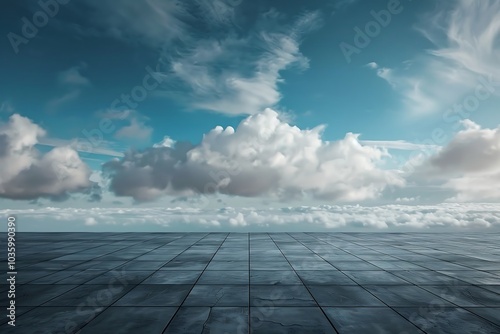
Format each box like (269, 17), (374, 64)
(0, 0), (500, 231)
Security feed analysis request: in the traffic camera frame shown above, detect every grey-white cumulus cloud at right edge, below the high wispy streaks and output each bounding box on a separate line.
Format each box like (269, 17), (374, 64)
(417, 120), (500, 202)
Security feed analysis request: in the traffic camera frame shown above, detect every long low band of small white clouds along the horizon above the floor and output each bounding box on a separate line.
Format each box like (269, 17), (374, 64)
(4, 204), (500, 231)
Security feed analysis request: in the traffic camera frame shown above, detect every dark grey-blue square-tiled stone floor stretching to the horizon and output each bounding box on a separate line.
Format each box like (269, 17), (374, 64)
(0, 233), (500, 334)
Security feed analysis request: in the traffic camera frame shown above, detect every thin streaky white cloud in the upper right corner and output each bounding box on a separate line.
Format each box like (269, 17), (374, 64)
(374, 0), (500, 115)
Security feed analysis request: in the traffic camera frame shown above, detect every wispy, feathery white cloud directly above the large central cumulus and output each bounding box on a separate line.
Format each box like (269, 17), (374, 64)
(163, 11), (321, 115)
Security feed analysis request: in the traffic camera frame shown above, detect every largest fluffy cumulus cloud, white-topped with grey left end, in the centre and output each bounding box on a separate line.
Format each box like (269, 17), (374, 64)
(104, 109), (404, 201)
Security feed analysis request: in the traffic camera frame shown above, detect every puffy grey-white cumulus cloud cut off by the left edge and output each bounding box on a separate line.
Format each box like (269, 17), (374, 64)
(0, 114), (90, 199)
